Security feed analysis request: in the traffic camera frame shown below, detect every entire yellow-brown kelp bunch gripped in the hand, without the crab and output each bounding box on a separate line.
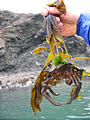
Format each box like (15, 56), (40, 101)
(31, 0), (90, 118)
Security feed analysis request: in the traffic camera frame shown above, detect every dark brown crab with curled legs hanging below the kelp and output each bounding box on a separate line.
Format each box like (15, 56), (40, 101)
(41, 63), (83, 106)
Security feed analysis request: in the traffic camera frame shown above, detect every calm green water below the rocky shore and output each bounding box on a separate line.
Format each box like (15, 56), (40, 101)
(0, 80), (90, 120)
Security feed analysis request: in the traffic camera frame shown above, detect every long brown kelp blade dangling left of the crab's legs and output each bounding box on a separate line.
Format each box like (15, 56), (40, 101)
(31, 67), (46, 116)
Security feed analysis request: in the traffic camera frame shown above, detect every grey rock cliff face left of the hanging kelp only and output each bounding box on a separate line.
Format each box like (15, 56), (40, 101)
(0, 11), (45, 72)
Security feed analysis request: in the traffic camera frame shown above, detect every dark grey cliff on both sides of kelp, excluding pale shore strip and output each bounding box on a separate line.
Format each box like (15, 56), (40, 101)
(0, 11), (90, 73)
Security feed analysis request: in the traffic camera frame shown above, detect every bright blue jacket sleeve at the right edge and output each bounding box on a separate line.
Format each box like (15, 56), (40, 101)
(76, 13), (90, 45)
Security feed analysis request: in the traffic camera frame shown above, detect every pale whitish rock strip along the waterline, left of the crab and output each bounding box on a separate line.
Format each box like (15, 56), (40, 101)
(0, 72), (39, 91)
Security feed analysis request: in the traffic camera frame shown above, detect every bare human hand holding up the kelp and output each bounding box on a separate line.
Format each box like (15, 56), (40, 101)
(41, 6), (80, 36)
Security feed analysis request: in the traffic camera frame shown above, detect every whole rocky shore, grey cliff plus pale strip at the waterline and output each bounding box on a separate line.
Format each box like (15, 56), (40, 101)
(0, 11), (90, 90)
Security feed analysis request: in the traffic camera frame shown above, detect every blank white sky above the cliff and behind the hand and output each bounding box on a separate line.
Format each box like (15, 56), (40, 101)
(0, 0), (90, 14)
